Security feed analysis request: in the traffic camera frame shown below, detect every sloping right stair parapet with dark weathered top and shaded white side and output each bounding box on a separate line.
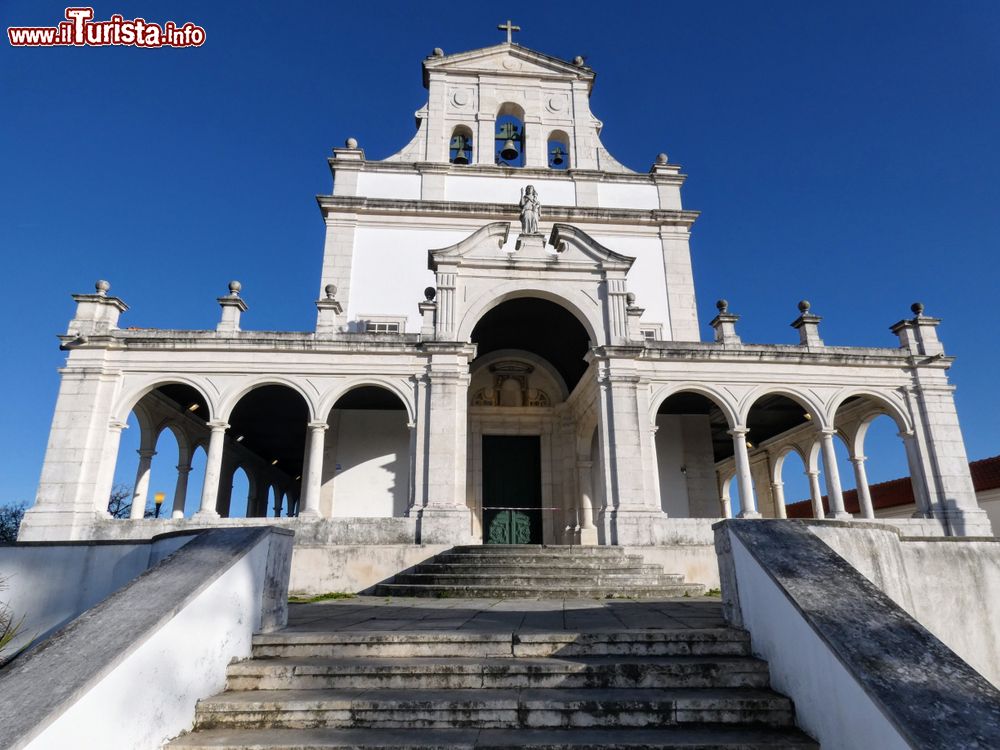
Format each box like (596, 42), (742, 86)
(716, 521), (1000, 750)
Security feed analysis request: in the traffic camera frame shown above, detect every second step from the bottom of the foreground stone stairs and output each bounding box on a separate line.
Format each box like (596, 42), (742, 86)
(195, 688), (793, 730)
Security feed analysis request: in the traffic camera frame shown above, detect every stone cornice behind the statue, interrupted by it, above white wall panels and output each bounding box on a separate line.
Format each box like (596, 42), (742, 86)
(316, 195), (699, 228)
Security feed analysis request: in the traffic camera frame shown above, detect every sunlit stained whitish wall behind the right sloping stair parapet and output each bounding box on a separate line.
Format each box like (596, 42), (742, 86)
(807, 522), (1000, 686)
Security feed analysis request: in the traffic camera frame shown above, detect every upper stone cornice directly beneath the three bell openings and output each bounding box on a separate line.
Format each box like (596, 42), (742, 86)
(327, 157), (687, 185)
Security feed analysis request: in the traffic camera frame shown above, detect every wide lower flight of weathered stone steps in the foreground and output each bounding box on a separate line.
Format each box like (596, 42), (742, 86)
(169, 628), (818, 750)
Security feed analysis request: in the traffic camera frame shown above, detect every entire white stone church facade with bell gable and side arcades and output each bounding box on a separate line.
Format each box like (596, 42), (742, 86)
(20, 35), (991, 545)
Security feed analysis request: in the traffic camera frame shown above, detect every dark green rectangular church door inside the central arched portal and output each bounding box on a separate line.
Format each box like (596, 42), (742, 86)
(483, 435), (542, 544)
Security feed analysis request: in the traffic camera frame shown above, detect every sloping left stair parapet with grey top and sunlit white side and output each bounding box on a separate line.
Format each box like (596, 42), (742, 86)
(0, 529), (291, 750)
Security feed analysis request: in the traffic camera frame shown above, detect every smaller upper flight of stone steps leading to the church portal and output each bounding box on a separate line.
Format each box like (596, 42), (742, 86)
(374, 545), (705, 599)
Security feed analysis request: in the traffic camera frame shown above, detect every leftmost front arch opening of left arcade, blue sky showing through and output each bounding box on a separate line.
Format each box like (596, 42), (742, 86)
(110, 383), (209, 519)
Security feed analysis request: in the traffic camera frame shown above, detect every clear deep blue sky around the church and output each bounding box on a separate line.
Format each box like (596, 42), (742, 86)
(0, 0), (1000, 503)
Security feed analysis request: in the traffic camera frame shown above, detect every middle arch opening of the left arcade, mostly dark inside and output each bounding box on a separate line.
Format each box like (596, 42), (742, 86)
(227, 385), (309, 518)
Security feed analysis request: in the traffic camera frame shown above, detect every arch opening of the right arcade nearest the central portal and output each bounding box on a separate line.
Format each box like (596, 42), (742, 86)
(654, 391), (740, 518)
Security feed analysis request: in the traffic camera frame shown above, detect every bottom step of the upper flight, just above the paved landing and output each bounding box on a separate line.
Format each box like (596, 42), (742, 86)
(375, 583), (705, 599)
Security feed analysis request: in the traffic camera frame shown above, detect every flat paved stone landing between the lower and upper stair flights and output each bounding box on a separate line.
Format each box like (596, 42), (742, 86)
(285, 596), (726, 633)
